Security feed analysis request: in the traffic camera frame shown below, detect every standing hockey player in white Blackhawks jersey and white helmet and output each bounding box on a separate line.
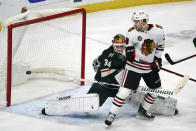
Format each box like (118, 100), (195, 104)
(105, 11), (165, 125)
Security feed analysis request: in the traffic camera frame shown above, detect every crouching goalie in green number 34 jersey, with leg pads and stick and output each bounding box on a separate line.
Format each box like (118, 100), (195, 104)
(42, 34), (188, 116)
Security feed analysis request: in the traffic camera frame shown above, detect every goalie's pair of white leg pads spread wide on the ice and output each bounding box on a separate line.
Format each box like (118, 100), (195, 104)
(42, 91), (181, 116)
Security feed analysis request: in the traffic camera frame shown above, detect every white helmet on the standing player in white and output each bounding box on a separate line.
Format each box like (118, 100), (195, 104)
(132, 10), (149, 23)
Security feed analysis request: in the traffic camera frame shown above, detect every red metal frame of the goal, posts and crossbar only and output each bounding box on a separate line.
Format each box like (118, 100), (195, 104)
(0, 8), (86, 106)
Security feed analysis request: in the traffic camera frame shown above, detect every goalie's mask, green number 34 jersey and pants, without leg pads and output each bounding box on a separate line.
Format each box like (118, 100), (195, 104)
(88, 34), (126, 106)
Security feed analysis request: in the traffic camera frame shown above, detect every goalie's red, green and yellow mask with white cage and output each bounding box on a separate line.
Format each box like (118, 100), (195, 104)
(112, 34), (126, 53)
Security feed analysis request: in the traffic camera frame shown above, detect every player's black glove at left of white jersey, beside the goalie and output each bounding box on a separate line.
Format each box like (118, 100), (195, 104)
(125, 46), (135, 62)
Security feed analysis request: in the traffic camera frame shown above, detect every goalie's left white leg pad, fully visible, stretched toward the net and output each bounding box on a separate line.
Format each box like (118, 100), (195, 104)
(45, 93), (99, 115)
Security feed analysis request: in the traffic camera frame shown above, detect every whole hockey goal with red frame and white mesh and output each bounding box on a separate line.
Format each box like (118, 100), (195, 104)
(0, 9), (86, 106)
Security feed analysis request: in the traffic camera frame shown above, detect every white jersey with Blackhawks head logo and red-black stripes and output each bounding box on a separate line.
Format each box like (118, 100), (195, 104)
(125, 24), (165, 73)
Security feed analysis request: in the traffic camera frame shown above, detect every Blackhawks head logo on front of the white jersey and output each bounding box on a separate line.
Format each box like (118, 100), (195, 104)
(141, 39), (156, 56)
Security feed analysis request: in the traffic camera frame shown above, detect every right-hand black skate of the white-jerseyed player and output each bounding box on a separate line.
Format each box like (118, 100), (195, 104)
(136, 105), (155, 120)
